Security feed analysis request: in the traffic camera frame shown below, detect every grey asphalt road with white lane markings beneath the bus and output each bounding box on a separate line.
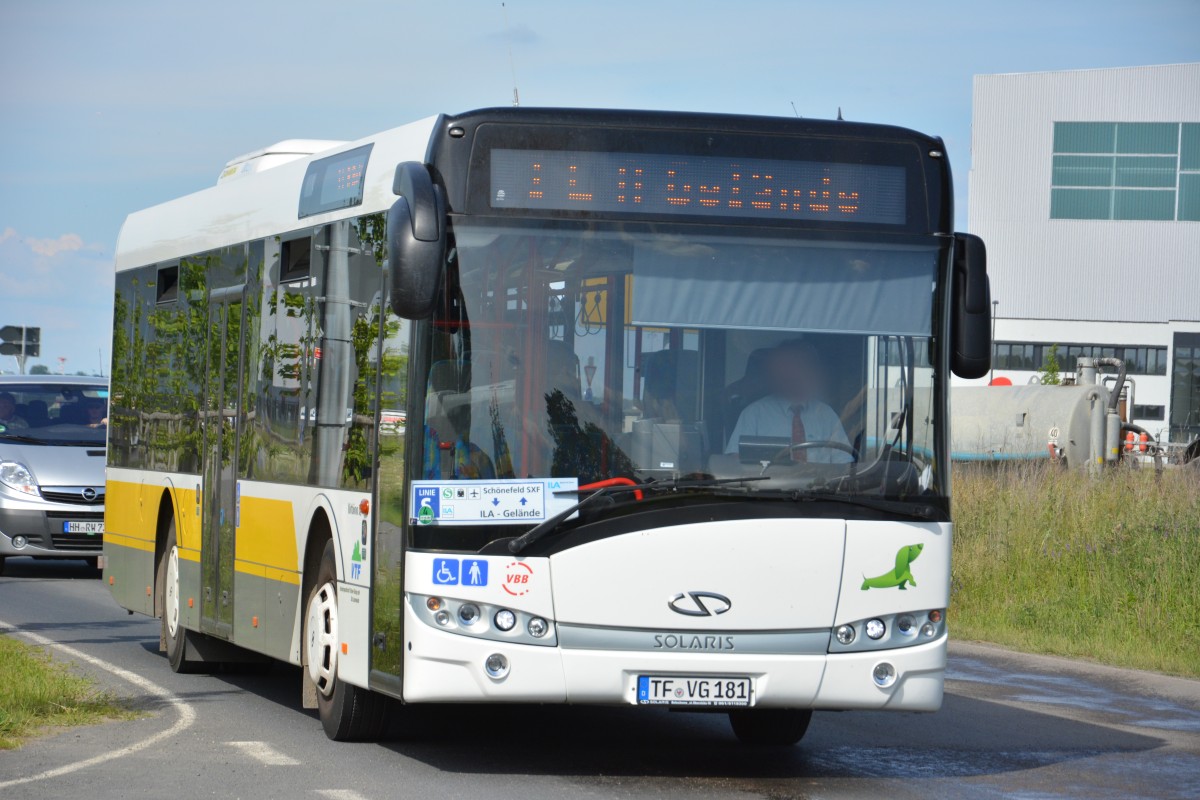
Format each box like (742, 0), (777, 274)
(0, 560), (1200, 800)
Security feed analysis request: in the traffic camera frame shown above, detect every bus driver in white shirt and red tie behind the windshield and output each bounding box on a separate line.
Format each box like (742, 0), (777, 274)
(725, 339), (852, 464)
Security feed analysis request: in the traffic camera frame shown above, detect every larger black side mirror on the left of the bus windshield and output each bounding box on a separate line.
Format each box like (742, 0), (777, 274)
(388, 161), (446, 319)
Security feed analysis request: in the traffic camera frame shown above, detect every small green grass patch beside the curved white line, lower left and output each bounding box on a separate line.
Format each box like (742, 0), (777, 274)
(0, 634), (137, 750)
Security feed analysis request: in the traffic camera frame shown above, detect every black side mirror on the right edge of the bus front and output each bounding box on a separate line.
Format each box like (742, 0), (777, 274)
(950, 234), (991, 378)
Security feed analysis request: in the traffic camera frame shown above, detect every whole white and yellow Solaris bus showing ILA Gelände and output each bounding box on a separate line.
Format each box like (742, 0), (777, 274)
(104, 109), (990, 744)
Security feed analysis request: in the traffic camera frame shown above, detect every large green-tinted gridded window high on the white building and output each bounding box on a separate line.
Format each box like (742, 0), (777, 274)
(1050, 122), (1200, 222)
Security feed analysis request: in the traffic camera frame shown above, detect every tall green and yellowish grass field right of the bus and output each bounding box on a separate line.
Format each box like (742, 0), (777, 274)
(950, 464), (1200, 678)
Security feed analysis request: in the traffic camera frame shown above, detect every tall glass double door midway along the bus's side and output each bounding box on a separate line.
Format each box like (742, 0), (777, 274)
(200, 285), (246, 639)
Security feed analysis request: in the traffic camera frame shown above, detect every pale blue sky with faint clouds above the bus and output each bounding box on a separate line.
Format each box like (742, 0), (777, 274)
(0, 0), (1200, 374)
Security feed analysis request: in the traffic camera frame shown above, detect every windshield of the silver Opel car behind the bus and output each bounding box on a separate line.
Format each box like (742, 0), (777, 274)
(0, 381), (108, 445)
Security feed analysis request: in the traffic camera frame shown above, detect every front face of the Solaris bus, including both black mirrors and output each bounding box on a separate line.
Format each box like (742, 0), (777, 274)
(372, 109), (990, 744)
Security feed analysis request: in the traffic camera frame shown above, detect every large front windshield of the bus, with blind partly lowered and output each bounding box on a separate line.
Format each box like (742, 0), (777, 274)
(420, 217), (948, 498)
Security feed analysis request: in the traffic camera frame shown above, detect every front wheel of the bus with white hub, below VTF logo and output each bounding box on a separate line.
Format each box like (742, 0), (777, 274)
(304, 541), (388, 741)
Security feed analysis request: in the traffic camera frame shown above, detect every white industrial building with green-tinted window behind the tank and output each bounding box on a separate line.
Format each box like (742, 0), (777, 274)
(967, 64), (1200, 441)
